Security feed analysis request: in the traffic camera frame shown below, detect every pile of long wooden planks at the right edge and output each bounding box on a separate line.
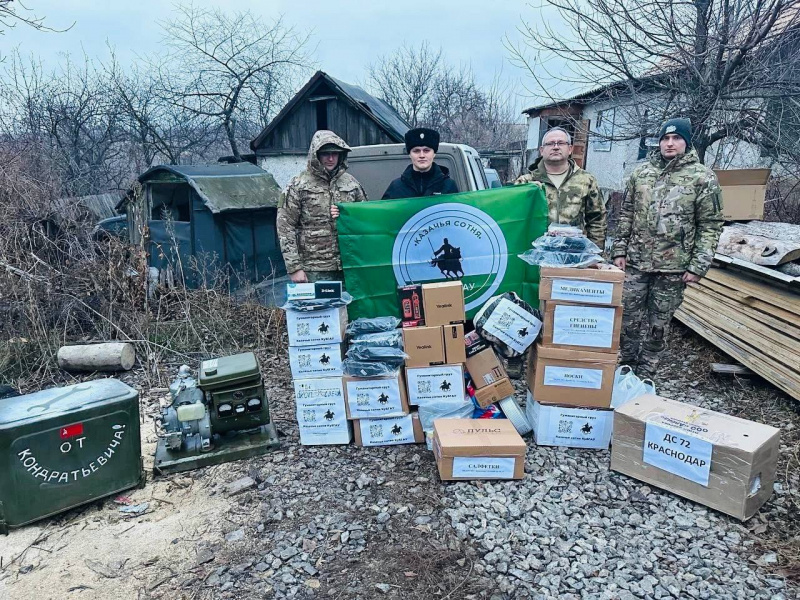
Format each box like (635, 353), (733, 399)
(675, 268), (800, 400)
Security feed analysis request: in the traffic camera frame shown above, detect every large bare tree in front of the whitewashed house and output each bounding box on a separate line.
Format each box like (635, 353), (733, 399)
(511, 0), (800, 160)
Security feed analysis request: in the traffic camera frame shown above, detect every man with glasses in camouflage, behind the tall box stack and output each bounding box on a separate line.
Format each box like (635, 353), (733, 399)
(514, 127), (606, 250)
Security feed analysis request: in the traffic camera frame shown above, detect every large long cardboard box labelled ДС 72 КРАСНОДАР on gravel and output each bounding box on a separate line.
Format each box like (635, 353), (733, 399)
(611, 395), (780, 521)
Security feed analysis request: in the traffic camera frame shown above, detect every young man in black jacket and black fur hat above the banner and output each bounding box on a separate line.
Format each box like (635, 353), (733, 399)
(382, 128), (458, 200)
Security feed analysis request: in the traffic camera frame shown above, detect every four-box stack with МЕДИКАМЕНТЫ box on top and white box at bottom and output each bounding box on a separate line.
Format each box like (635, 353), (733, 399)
(526, 265), (625, 448)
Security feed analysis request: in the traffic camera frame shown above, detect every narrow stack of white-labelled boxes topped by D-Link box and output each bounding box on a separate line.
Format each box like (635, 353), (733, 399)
(286, 282), (352, 446)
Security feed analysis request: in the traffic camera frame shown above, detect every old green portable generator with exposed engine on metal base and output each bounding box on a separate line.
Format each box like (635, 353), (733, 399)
(154, 352), (279, 474)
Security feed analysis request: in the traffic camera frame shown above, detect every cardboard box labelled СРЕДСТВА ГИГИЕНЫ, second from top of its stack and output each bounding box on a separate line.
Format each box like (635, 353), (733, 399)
(542, 301), (622, 353)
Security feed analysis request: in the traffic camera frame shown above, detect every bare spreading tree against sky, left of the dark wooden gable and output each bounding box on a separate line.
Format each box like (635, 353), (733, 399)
(149, 5), (309, 160)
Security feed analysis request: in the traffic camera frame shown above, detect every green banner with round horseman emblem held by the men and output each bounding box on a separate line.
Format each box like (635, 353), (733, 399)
(338, 185), (547, 320)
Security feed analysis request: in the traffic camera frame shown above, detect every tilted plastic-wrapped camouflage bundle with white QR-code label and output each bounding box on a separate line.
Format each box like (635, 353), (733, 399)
(474, 292), (542, 358)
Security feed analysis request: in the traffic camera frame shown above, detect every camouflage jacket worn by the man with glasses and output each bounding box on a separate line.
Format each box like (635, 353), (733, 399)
(514, 158), (606, 250)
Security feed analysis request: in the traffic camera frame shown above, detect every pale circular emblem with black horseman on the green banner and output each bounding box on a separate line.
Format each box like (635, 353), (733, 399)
(392, 202), (508, 310)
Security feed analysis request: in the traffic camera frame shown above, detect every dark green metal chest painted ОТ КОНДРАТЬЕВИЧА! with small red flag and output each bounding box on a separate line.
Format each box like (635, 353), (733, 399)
(0, 379), (144, 534)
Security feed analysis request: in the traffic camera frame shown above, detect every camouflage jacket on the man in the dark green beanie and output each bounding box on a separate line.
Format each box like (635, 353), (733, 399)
(611, 150), (722, 277)
